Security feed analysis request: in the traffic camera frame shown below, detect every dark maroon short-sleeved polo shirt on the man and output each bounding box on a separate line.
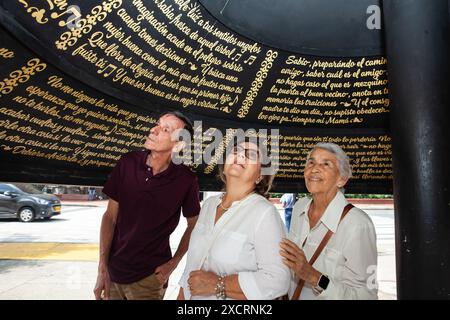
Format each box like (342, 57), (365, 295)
(103, 151), (200, 284)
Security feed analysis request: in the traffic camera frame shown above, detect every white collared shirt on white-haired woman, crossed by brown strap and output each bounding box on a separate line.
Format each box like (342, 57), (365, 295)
(288, 191), (377, 300)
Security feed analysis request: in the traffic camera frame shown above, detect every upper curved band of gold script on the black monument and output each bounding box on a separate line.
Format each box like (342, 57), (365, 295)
(2, 0), (389, 127)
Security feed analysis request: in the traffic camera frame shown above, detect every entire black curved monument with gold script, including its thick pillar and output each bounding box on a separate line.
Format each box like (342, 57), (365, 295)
(0, 0), (450, 299)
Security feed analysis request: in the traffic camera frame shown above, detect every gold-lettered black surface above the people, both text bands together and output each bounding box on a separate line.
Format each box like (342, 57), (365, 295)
(0, 0), (392, 192)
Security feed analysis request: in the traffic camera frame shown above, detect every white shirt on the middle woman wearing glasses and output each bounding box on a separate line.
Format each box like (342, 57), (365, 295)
(179, 194), (290, 300)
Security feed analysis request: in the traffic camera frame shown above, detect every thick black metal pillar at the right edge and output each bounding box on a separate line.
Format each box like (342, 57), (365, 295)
(383, 0), (450, 299)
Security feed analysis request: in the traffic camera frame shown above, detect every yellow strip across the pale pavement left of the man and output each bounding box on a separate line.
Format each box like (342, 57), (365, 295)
(0, 242), (98, 261)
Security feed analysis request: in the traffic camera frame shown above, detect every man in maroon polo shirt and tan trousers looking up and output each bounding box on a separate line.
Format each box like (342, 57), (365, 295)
(94, 112), (200, 300)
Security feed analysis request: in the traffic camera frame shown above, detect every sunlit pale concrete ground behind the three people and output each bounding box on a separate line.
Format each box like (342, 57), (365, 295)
(0, 201), (396, 300)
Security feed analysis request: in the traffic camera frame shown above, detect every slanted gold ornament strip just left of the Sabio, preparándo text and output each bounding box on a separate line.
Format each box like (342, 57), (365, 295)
(237, 50), (278, 118)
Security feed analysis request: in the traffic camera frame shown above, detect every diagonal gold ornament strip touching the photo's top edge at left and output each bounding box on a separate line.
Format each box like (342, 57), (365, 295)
(55, 0), (122, 51)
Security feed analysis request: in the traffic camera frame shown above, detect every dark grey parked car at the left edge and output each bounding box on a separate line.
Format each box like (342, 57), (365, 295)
(0, 183), (61, 222)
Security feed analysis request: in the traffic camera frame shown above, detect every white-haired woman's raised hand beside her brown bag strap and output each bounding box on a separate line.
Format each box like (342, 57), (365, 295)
(280, 239), (321, 286)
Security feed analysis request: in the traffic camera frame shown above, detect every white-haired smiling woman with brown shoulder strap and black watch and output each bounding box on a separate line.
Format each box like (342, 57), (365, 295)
(280, 143), (377, 300)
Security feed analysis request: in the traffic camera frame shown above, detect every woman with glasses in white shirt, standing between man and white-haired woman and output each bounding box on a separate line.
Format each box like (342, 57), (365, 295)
(178, 142), (290, 300)
